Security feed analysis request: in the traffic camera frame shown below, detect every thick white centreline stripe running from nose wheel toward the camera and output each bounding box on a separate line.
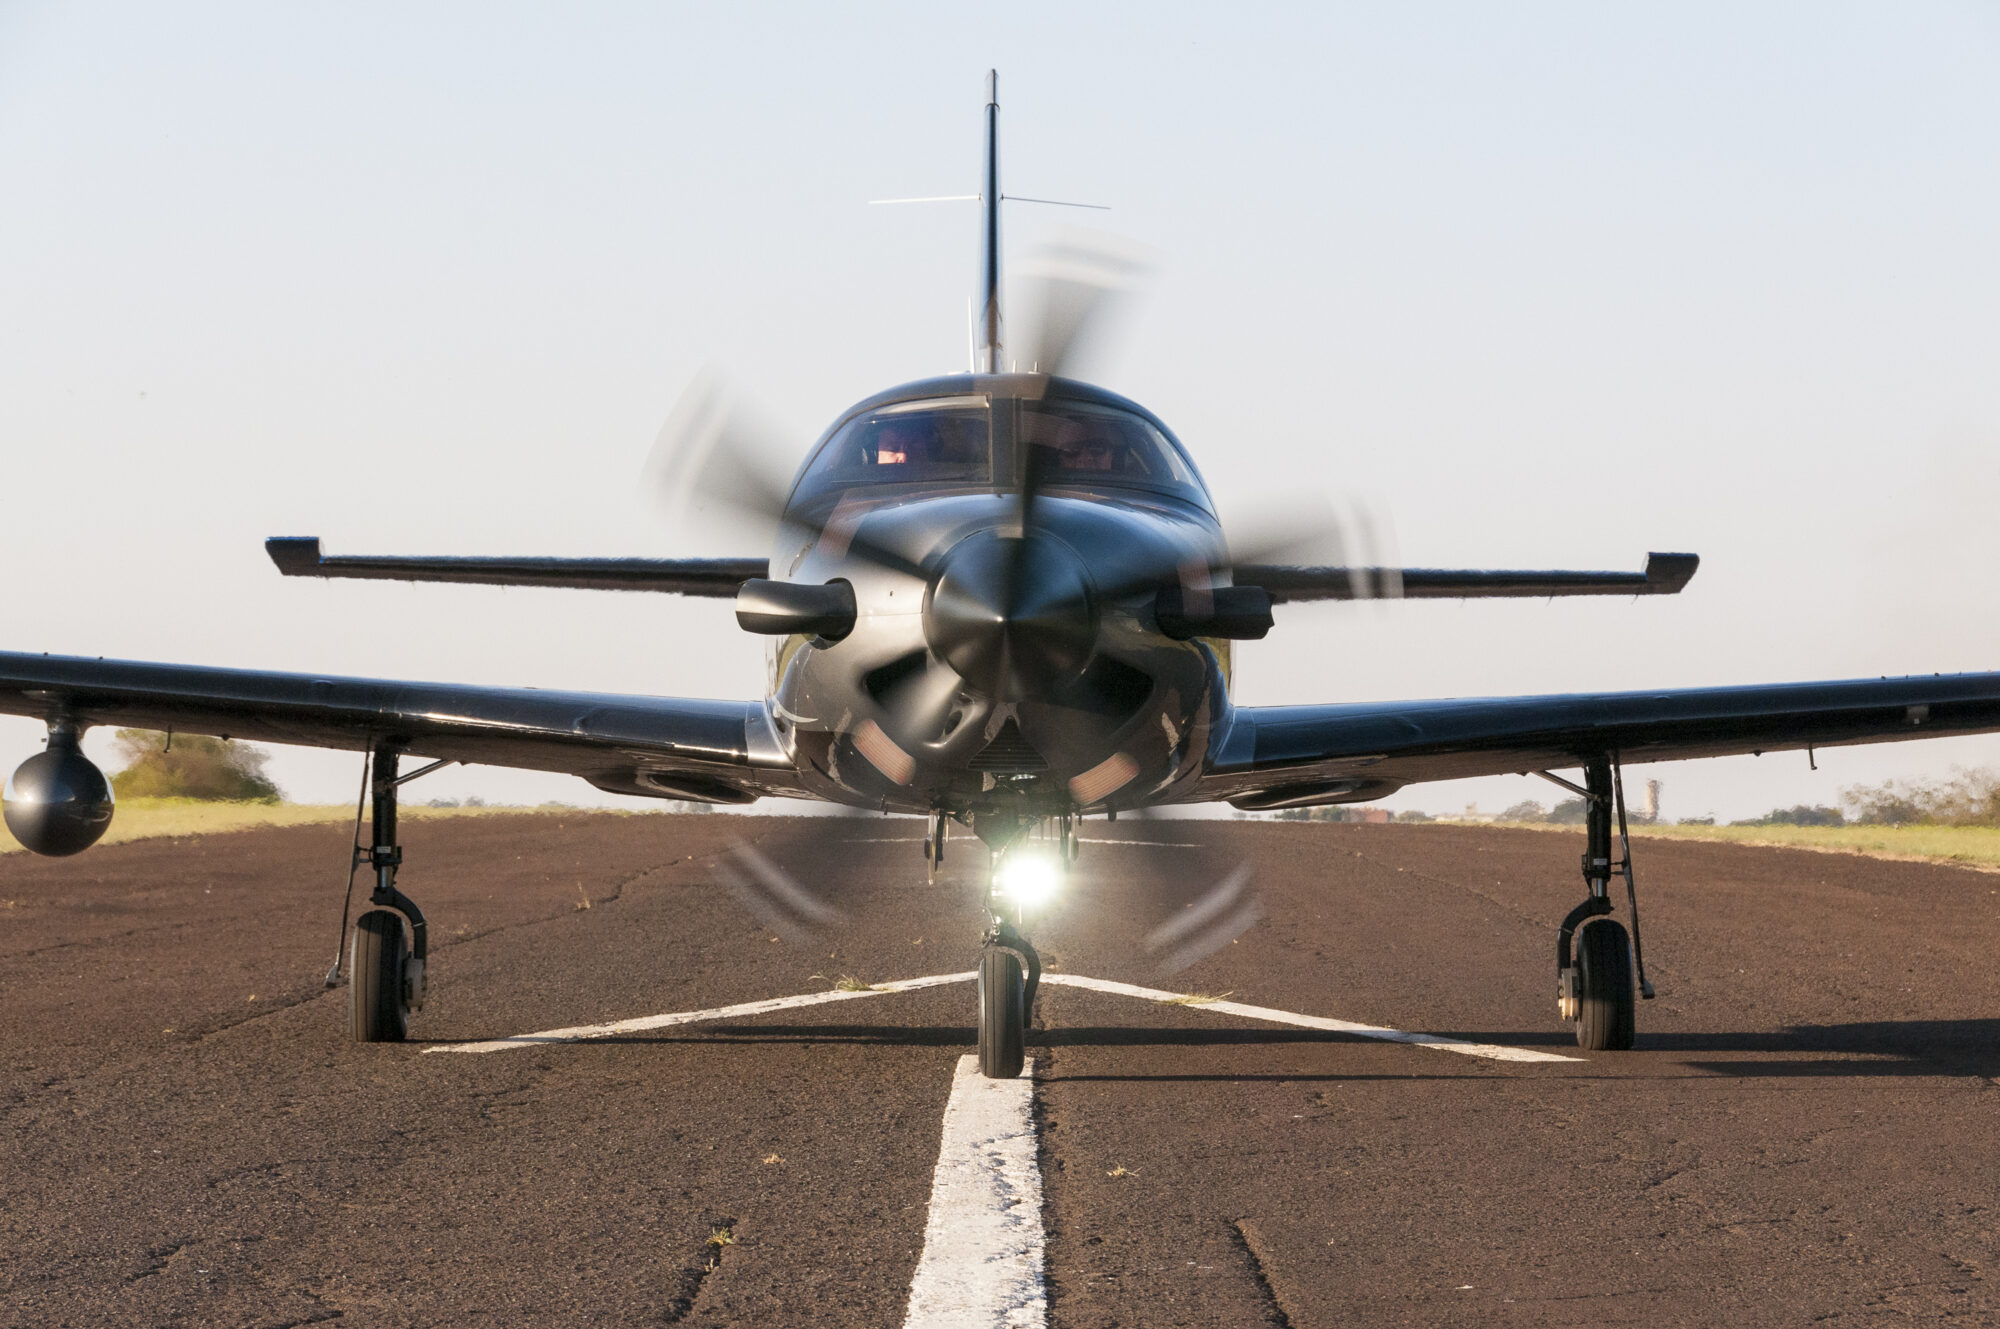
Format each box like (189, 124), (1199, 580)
(902, 1057), (1048, 1329)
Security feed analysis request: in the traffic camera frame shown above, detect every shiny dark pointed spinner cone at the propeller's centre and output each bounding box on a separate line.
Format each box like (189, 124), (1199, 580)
(924, 530), (1098, 701)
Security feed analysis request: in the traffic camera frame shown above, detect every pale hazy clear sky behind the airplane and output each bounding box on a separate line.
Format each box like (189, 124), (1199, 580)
(0, 0), (2000, 817)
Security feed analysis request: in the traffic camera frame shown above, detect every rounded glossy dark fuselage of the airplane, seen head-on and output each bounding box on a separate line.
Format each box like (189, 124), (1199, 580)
(768, 374), (1228, 819)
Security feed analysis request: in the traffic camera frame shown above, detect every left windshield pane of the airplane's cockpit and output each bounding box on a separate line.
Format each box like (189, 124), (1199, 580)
(798, 398), (992, 496)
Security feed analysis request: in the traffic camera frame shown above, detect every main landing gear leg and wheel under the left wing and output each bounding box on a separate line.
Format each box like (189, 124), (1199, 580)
(348, 745), (430, 1043)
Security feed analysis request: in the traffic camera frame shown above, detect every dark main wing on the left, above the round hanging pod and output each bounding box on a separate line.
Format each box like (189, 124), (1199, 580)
(0, 652), (796, 803)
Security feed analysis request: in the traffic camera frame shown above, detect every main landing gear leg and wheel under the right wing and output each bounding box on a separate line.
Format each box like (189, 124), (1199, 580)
(1544, 757), (1652, 1053)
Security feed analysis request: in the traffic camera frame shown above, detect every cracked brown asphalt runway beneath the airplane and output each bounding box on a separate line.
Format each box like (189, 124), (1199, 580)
(0, 813), (2000, 1329)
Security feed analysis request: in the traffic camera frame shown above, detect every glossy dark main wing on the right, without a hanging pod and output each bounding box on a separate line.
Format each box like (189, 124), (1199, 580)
(1194, 673), (2000, 809)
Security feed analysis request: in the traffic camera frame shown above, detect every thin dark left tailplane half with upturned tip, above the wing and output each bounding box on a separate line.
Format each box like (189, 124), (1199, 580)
(264, 536), (770, 596)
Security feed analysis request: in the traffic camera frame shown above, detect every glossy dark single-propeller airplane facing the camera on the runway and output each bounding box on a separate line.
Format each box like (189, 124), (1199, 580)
(0, 74), (2000, 1077)
